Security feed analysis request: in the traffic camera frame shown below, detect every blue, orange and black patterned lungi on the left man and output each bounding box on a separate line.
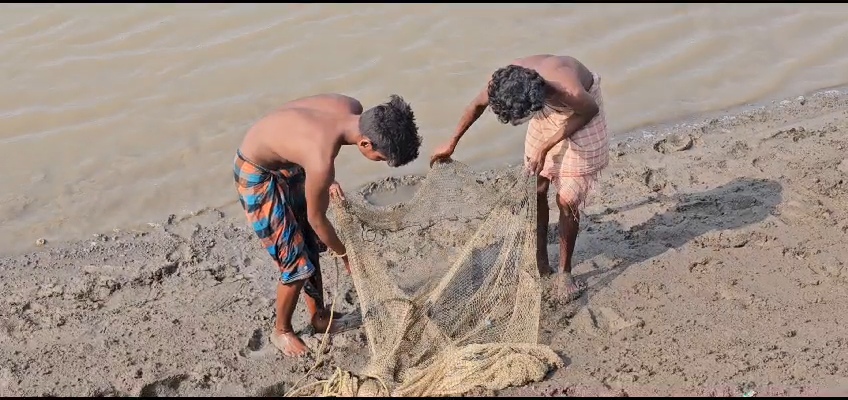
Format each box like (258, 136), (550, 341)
(233, 151), (327, 304)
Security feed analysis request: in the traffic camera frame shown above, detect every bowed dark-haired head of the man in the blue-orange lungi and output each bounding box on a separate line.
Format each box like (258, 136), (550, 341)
(359, 94), (421, 167)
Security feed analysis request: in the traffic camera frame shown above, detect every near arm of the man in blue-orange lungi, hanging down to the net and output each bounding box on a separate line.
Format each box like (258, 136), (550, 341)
(305, 164), (347, 254)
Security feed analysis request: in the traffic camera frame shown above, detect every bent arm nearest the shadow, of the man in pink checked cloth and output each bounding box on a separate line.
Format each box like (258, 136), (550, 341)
(543, 68), (600, 151)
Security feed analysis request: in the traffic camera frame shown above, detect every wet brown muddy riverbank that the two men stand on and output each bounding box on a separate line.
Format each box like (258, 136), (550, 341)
(0, 87), (848, 396)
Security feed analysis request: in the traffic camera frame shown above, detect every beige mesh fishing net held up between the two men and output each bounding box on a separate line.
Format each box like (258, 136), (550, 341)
(300, 161), (562, 396)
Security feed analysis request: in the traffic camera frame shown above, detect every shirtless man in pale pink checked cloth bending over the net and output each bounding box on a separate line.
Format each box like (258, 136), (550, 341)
(430, 54), (609, 302)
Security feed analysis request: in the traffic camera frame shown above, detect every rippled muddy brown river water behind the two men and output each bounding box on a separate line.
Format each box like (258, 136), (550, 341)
(0, 4), (848, 251)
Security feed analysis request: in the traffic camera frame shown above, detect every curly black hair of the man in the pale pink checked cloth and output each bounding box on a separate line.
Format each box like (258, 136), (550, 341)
(489, 65), (548, 125)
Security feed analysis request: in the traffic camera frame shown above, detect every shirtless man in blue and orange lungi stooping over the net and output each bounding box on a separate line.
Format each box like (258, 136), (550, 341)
(234, 94), (421, 356)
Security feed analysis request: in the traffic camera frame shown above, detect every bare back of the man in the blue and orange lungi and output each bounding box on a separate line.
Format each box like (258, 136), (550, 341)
(239, 94), (362, 171)
